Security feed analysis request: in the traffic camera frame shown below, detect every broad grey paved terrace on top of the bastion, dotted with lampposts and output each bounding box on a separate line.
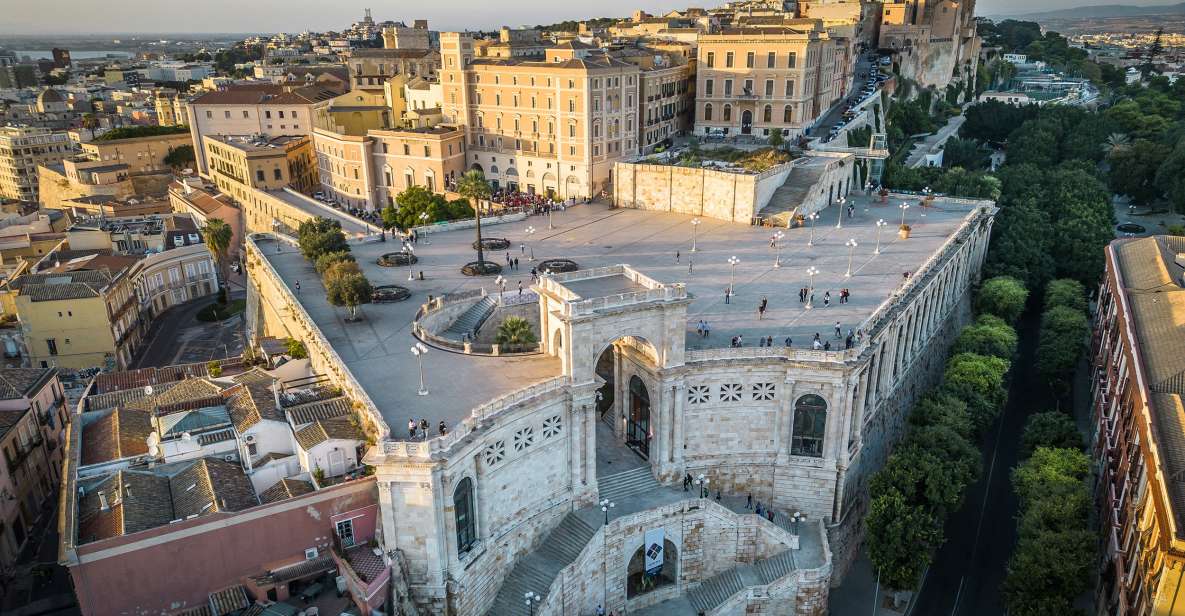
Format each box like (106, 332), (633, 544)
(256, 193), (976, 438)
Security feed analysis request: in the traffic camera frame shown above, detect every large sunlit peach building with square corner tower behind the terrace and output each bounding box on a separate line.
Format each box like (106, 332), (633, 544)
(441, 32), (641, 198)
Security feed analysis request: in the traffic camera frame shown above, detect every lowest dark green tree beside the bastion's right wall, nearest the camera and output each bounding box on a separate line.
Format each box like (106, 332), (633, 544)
(864, 490), (942, 590)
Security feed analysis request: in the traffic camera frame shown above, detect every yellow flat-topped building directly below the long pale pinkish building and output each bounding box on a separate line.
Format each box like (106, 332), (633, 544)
(203, 135), (318, 200)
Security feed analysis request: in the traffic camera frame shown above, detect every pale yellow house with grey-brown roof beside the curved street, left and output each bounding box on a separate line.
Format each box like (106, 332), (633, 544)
(12, 256), (142, 370)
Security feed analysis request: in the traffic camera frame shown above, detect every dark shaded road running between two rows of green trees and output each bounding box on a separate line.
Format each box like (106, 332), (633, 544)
(910, 309), (1055, 616)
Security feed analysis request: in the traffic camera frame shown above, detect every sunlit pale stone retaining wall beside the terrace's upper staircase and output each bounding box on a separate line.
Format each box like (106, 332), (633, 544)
(613, 162), (793, 224)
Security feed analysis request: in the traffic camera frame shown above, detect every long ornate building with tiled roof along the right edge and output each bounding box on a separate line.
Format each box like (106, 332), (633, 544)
(1091, 236), (1185, 616)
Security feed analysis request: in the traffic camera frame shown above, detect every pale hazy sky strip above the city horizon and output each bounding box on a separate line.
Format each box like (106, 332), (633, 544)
(0, 0), (1162, 34)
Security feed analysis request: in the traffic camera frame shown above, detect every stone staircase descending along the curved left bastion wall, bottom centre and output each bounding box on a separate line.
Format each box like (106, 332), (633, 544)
(486, 513), (596, 616)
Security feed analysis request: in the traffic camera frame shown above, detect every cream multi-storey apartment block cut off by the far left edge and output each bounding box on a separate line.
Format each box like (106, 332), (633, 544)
(0, 127), (73, 203)
